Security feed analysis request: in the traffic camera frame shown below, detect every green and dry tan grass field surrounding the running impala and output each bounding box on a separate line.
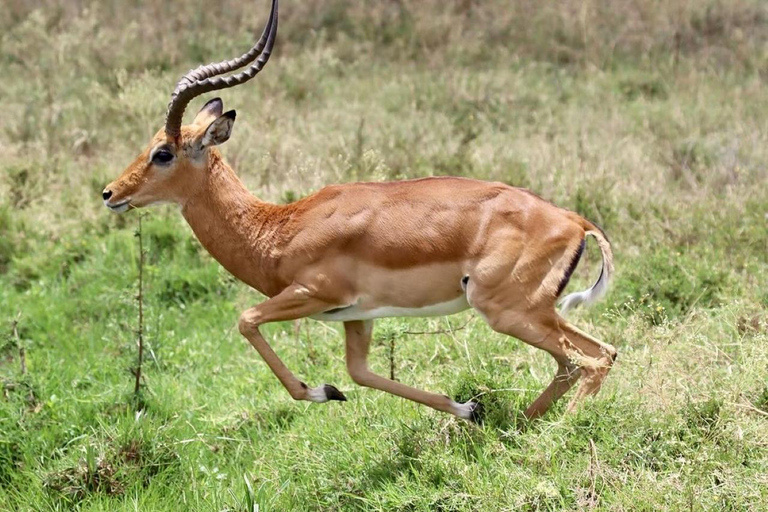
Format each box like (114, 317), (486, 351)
(0, 0), (768, 512)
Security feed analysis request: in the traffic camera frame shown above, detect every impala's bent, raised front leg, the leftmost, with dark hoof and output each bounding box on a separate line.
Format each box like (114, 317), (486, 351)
(238, 284), (346, 402)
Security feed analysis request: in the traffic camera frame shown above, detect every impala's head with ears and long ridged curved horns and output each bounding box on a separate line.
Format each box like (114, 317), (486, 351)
(102, 0), (277, 213)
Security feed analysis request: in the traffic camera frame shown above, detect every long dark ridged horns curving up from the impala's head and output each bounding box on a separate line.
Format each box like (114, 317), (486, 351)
(165, 0), (277, 138)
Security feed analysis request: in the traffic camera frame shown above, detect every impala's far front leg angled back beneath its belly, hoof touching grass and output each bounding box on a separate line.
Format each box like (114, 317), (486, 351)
(344, 320), (477, 419)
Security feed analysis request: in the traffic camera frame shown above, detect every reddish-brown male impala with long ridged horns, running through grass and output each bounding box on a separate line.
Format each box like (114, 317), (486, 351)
(103, 0), (616, 418)
